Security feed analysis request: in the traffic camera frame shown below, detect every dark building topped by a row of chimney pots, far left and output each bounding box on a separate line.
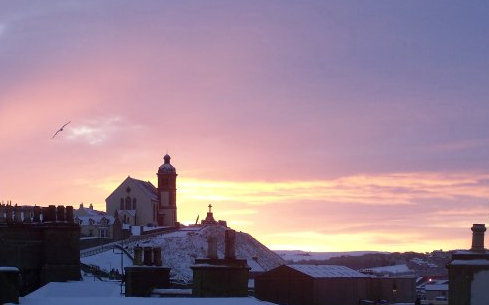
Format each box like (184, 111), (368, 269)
(0, 205), (80, 295)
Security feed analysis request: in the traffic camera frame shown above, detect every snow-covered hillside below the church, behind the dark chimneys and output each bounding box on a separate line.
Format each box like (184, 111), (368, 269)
(81, 225), (285, 282)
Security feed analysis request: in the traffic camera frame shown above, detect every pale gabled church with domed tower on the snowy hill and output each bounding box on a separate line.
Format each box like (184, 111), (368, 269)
(105, 154), (178, 227)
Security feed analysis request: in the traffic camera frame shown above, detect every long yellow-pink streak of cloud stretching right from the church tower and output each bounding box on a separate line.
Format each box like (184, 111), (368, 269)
(180, 172), (489, 205)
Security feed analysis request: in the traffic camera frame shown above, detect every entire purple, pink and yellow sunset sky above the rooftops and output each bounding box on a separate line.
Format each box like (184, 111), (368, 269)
(0, 0), (489, 252)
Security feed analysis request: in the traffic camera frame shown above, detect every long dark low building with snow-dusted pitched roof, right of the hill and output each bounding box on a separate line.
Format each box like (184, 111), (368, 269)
(255, 265), (416, 305)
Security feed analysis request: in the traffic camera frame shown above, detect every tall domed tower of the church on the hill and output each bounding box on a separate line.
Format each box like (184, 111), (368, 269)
(157, 154), (177, 227)
